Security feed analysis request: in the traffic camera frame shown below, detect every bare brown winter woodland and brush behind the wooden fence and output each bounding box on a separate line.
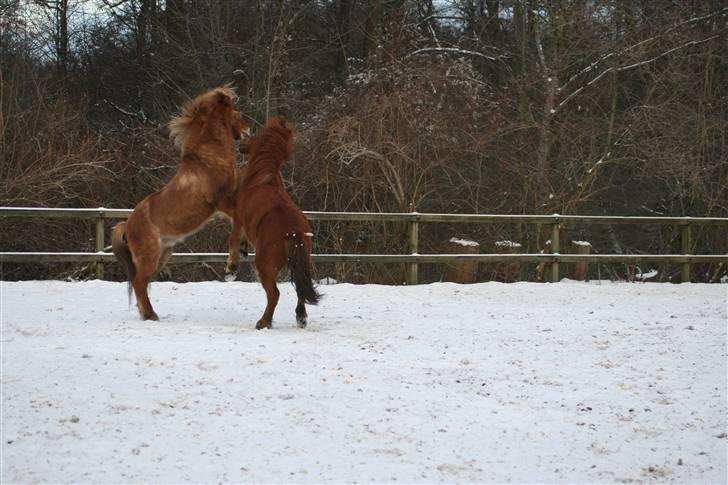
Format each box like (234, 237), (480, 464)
(0, 0), (728, 283)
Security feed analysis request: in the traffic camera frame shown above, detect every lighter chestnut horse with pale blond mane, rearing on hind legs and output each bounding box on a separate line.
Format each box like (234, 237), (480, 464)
(111, 86), (250, 320)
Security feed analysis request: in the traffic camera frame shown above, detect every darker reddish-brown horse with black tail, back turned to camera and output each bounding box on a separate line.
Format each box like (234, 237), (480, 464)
(221, 118), (321, 329)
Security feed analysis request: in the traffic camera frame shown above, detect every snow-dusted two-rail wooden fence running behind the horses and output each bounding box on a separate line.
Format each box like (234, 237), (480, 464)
(0, 207), (728, 284)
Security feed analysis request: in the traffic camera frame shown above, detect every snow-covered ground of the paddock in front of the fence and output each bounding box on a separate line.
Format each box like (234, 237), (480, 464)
(0, 281), (728, 483)
